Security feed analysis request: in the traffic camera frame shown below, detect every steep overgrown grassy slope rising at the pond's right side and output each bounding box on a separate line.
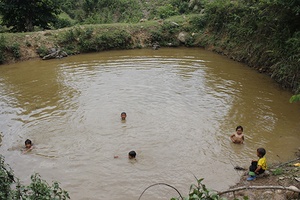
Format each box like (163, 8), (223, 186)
(198, 0), (300, 93)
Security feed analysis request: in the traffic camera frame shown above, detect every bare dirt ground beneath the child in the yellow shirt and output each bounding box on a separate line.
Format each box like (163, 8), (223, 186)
(222, 149), (300, 200)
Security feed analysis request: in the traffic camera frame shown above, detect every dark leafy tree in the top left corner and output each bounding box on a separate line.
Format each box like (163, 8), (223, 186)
(0, 0), (61, 32)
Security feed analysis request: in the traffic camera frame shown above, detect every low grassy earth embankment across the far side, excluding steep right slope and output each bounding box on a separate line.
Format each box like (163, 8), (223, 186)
(0, 16), (190, 64)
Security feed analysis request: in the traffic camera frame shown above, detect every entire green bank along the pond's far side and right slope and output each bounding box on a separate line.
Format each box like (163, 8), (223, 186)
(0, 0), (300, 93)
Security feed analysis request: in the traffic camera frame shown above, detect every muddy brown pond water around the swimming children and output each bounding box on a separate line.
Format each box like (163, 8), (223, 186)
(0, 48), (300, 200)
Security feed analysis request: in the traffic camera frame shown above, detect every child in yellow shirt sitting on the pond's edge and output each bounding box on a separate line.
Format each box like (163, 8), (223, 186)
(247, 148), (267, 181)
